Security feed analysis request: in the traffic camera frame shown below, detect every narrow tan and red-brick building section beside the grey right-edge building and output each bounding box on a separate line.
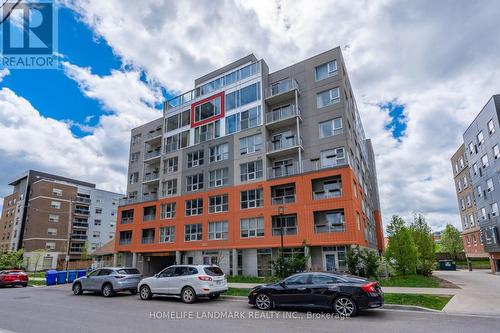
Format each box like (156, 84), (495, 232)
(451, 144), (488, 258)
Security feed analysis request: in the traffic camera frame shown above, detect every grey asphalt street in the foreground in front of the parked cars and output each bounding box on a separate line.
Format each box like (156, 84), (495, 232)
(0, 285), (500, 333)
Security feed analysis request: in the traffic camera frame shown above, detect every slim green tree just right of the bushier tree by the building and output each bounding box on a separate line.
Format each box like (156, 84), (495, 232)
(410, 214), (436, 276)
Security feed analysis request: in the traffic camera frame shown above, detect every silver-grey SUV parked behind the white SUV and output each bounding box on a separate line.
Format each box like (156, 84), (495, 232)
(72, 267), (142, 297)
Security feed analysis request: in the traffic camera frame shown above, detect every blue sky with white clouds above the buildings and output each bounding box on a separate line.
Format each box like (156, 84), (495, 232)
(0, 0), (500, 230)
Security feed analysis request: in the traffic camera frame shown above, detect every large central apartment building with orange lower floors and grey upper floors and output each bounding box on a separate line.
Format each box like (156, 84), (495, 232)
(115, 47), (383, 276)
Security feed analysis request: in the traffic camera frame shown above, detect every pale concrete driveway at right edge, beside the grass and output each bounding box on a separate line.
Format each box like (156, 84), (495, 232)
(434, 269), (500, 316)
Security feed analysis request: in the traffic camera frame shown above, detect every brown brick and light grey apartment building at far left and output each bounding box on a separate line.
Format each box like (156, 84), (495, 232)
(0, 170), (123, 269)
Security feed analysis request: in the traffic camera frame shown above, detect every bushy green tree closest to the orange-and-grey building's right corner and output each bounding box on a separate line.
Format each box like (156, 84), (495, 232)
(385, 215), (417, 275)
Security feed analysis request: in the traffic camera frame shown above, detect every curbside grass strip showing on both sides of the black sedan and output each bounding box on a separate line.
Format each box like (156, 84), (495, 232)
(224, 288), (453, 310)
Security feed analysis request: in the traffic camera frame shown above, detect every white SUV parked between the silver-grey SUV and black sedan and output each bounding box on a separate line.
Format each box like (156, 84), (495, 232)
(139, 265), (227, 303)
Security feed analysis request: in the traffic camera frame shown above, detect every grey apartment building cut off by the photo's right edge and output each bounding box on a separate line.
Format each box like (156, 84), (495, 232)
(456, 95), (500, 272)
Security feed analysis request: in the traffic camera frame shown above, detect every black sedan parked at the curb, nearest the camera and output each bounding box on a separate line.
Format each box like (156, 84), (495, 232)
(248, 272), (384, 317)
